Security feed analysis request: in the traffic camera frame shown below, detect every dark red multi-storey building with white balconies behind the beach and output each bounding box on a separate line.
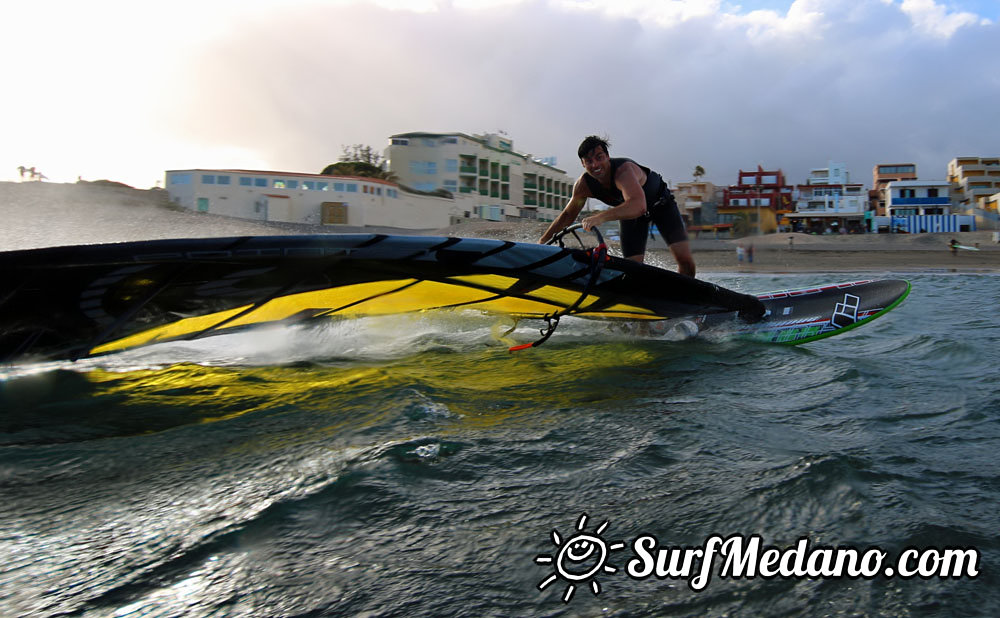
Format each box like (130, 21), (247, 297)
(718, 165), (793, 235)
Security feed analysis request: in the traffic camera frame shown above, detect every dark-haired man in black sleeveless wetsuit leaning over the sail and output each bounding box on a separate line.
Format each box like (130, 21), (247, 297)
(539, 135), (695, 277)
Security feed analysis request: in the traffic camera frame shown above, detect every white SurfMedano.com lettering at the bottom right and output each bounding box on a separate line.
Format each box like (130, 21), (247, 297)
(625, 534), (979, 591)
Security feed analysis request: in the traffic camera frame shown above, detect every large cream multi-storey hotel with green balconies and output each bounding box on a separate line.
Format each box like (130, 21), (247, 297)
(385, 132), (573, 221)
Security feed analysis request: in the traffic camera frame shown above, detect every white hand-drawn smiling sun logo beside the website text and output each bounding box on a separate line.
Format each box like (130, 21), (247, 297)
(535, 513), (625, 603)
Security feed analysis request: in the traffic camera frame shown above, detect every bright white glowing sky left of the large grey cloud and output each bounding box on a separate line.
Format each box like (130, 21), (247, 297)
(0, 0), (281, 188)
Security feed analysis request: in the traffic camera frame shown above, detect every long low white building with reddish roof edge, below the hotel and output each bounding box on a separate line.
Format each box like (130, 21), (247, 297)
(166, 169), (464, 231)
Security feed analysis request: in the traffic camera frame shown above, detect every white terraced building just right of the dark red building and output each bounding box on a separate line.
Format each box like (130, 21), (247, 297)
(788, 161), (868, 234)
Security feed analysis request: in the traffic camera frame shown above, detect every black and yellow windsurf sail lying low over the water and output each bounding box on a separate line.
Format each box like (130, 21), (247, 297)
(0, 234), (747, 362)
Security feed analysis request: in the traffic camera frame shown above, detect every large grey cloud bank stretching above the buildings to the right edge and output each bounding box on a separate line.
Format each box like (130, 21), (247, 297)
(171, 0), (1000, 184)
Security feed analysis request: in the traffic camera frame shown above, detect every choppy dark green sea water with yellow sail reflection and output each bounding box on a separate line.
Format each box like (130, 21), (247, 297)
(0, 272), (1000, 616)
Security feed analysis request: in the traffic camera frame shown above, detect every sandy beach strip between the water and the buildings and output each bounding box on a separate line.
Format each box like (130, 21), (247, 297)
(0, 182), (1000, 273)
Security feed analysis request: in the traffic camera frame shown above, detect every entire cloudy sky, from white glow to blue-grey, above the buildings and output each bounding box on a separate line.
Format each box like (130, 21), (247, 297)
(0, 0), (1000, 188)
